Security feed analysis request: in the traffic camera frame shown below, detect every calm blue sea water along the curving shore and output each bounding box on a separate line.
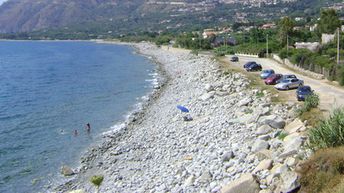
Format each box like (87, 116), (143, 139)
(0, 41), (155, 193)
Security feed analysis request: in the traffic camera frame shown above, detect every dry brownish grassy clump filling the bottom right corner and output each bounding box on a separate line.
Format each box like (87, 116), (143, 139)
(299, 147), (344, 193)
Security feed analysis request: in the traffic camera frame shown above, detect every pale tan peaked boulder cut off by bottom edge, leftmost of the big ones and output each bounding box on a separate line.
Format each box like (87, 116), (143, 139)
(221, 174), (260, 193)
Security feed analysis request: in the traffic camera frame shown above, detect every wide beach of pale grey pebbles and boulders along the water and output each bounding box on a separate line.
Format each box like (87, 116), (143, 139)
(56, 43), (307, 193)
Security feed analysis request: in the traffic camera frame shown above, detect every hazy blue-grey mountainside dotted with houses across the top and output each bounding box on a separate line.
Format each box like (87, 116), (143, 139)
(0, 0), (338, 33)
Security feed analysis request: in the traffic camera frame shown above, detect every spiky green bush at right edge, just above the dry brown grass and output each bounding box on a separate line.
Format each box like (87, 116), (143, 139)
(308, 109), (344, 149)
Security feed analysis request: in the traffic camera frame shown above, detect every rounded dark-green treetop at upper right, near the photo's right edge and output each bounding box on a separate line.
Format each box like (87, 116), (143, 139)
(318, 9), (340, 34)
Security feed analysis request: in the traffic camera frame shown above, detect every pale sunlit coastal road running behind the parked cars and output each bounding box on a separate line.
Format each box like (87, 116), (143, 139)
(227, 57), (344, 110)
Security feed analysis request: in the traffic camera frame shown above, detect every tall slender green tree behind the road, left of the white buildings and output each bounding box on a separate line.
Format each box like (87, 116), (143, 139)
(278, 17), (294, 46)
